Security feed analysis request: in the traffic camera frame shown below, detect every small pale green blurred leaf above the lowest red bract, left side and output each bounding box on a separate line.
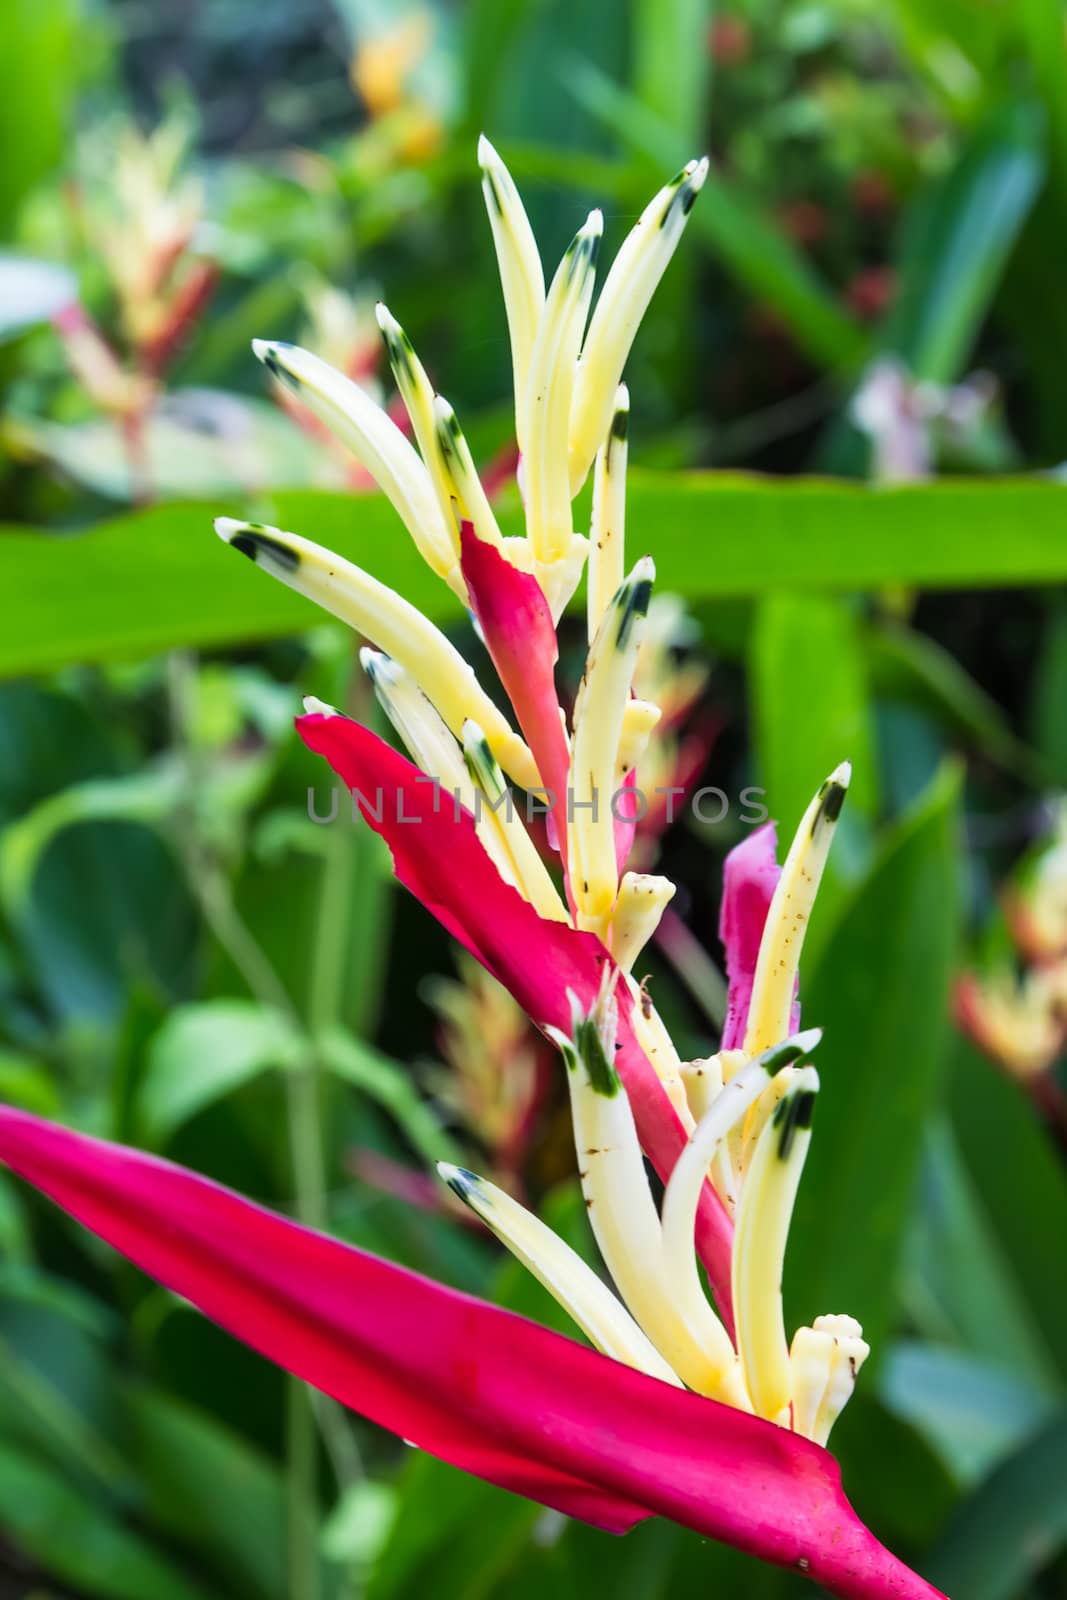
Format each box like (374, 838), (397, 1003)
(141, 1000), (306, 1142)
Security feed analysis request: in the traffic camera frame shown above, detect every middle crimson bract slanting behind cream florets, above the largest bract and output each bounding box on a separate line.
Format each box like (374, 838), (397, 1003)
(296, 714), (733, 1326)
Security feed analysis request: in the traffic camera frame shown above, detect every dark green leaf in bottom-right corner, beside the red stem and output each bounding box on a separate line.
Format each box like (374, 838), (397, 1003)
(925, 1411), (1067, 1600)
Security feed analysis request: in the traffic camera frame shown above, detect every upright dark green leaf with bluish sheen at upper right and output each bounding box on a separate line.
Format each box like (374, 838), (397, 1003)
(880, 102), (1062, 384)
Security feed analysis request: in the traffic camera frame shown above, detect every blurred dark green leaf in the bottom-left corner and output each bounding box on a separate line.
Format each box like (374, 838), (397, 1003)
(0, 1443), (210, 1600)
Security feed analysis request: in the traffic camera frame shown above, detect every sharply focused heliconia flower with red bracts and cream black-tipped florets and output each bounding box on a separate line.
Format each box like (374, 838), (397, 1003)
(0, 142), (934, 1597)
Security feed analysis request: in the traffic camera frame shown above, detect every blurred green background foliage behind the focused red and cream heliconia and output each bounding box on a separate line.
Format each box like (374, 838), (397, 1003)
(0, 0), (1067, 1600)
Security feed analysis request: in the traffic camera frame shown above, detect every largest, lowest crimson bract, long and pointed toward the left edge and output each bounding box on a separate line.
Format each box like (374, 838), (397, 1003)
(0, 1107), (936, 1600)
